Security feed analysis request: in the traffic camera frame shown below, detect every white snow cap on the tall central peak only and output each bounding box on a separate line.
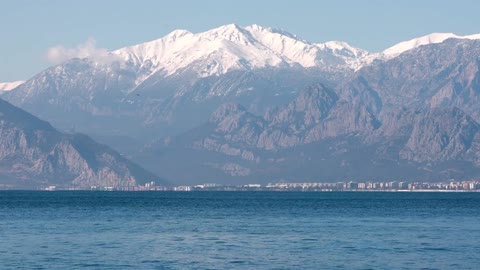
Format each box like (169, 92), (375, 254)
(113, 24), (368, 80)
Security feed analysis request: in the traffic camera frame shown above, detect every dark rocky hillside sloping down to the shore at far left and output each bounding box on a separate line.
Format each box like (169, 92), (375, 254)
(0, 100), (159, 188)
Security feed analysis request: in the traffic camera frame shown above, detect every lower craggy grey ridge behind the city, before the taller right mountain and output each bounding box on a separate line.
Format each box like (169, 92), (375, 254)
(135, 85), (480, 183)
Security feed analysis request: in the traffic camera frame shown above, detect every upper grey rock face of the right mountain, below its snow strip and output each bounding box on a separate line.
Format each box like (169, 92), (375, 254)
(339, 39), (480, 122)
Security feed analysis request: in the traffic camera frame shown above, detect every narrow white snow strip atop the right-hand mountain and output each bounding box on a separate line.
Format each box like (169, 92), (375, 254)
(381, 33), (480, 59)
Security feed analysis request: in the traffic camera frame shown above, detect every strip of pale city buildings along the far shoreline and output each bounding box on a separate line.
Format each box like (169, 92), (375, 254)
(35, 180), (480, 192)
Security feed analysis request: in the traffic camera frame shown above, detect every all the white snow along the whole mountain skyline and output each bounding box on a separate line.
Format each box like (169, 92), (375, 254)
(8, 24), (480, 104)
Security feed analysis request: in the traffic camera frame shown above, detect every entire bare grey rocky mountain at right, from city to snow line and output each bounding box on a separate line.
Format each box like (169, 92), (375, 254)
(135, 35), (480, 184)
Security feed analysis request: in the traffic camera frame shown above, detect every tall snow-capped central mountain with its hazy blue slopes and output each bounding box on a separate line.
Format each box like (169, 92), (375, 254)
(0, 24), (368, 141)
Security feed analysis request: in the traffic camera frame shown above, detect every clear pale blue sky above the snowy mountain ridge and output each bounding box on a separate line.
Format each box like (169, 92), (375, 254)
(0, 0), (480, 81)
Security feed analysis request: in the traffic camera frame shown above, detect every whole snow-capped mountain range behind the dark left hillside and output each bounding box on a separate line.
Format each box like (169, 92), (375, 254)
(2, 24), (480, 187)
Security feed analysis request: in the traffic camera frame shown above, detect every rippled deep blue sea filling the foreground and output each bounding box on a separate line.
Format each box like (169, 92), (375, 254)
(0, 191), (480, 269)
